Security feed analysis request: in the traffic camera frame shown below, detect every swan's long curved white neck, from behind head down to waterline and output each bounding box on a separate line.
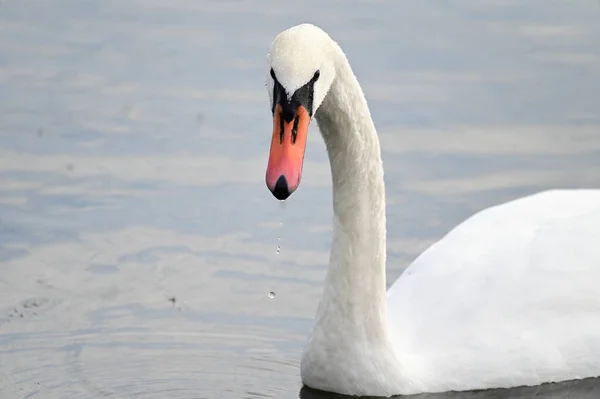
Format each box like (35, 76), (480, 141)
(301, 46), (400, 395)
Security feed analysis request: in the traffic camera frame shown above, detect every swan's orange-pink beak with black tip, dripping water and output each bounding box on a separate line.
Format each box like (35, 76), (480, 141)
(267, 104), (310, 201)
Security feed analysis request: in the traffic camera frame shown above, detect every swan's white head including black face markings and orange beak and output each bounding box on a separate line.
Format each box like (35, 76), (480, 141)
(266, 24), (335, 200)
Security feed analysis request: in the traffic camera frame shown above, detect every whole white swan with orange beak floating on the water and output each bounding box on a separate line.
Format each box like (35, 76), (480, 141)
(265, 24), (600, 397)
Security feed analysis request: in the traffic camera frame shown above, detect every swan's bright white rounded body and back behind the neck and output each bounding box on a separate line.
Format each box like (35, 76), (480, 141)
(388, 190), (600, 391)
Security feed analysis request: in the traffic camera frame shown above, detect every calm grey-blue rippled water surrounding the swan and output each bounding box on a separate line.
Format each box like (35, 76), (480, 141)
(0, 0), (600, 399)
